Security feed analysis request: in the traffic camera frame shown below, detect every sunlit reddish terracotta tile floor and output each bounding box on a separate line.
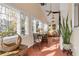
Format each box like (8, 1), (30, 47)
(17, 37), (66, 56)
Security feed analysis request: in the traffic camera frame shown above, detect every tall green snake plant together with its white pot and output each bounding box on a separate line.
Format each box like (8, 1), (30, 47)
(60, 16), (72, 50)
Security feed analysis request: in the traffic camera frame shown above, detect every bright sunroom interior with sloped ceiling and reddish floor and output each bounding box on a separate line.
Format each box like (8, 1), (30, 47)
(0, 3), (79, 56)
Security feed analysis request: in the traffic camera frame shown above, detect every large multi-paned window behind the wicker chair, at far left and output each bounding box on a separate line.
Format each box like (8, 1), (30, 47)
(0, 5), (17, 36)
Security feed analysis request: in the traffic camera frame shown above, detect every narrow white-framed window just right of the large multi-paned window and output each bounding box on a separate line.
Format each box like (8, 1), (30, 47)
(20, 13), (29, 35)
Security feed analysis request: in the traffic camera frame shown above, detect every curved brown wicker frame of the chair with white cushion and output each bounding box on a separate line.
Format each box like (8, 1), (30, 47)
(0, 35), (22, 52)
